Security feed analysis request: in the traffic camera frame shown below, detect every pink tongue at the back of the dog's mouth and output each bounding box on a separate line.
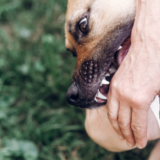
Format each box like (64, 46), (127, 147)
(117, 37), (131, 66)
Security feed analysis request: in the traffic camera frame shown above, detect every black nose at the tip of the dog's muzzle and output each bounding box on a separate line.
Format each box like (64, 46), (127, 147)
(66, 82), (78, 105)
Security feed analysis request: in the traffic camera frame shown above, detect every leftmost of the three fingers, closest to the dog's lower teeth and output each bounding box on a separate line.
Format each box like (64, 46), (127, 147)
(107, 93), (124, 139)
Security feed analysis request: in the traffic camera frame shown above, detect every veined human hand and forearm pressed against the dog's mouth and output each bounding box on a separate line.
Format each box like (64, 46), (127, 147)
(107, 0), (160, 149)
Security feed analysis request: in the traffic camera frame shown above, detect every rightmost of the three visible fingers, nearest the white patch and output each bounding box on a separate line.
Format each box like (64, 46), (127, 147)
(131, 108), (148, 149)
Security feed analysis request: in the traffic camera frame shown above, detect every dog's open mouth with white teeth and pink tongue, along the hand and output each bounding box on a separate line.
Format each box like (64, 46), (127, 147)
(94, 37), (131, 104)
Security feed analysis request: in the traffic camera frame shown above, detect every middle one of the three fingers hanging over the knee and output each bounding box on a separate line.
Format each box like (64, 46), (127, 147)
(118, 102), (135, 147)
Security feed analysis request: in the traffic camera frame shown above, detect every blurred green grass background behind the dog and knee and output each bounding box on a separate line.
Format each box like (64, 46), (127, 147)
(0, 0), (156, 160)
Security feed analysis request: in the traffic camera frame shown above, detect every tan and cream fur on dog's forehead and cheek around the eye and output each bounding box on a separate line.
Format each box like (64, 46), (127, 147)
(65, 0), (135, 68)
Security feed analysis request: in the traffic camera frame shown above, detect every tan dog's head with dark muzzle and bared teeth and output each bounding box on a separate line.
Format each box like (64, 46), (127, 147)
(65, 0), (135, 108)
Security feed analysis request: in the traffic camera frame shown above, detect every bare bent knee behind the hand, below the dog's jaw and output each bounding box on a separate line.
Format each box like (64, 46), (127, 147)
(85, 106), (160, 152)
